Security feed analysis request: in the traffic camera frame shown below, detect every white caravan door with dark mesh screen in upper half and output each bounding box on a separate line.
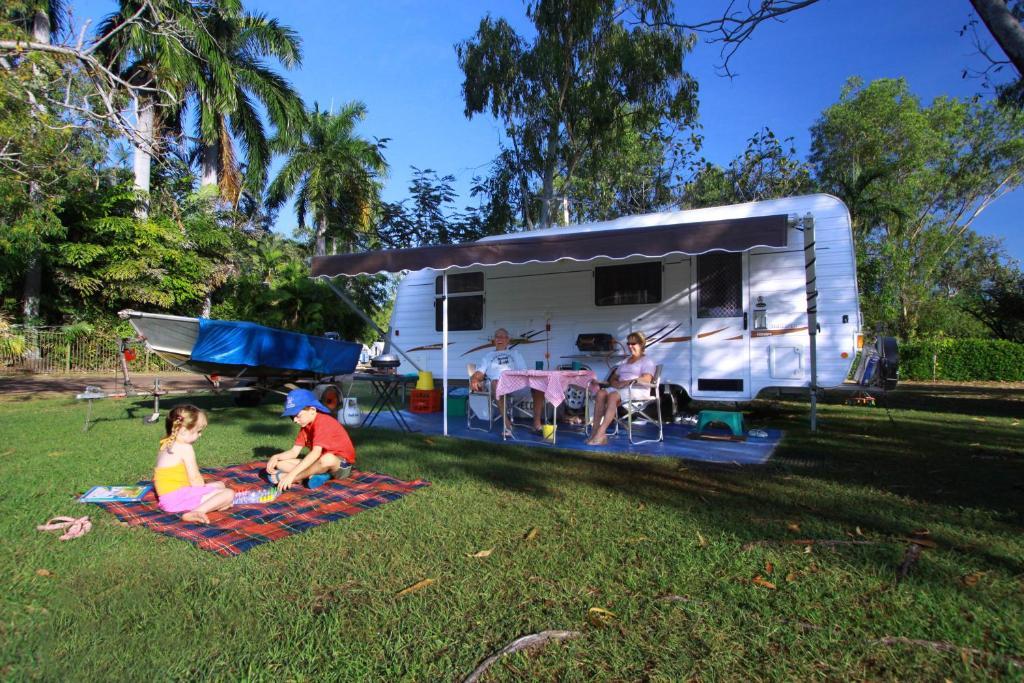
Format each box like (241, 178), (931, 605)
(690, 252), (751, 400)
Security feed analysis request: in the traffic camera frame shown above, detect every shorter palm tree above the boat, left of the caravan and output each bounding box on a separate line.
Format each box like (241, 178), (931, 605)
(267, 102), (387, 256)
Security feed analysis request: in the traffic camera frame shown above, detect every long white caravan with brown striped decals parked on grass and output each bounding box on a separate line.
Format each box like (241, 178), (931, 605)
(366, 195), (861, 401)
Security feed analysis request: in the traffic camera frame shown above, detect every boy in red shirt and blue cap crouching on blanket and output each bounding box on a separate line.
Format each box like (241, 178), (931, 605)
(266, 389), (355, 490)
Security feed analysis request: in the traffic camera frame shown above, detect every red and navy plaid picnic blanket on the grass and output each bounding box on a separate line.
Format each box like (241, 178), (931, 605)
(96, 462), (430, 557)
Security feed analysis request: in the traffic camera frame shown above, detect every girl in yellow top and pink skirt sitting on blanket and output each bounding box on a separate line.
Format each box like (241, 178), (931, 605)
(153, 403), (234, 524)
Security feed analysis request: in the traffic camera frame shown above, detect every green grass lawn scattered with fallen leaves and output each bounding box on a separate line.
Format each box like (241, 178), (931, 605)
(0, 387), (1024, 681)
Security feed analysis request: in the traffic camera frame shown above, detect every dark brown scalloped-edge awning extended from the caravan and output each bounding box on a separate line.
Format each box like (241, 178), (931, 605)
(312, 215), (788, 278)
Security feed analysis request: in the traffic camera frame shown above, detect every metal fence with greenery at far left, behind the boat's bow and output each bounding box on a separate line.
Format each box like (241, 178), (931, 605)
(0, 326), (180, 375)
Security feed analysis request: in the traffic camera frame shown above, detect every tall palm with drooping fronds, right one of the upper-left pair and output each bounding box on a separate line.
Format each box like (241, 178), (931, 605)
(188, 0), (305, 204)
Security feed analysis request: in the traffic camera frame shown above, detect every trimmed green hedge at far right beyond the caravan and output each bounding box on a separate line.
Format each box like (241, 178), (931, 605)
(899, 339), (1024, 382)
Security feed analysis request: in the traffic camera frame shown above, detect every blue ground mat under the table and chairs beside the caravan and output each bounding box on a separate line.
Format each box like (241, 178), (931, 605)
(364, 411), (782, 465)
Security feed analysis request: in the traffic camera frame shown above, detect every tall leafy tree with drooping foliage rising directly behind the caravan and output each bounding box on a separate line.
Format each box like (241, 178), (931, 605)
(456, 0), (696, 227)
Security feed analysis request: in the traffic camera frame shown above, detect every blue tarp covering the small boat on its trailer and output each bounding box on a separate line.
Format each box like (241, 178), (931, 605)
(190, 317), (362, 375)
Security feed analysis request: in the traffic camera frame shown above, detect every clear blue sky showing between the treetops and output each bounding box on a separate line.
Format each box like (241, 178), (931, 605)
(73, 0), (1024, 260)
